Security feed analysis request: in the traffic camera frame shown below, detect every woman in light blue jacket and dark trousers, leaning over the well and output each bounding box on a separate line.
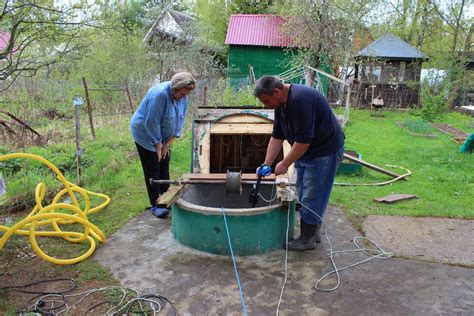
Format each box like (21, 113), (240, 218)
(130, 72), (196, 217)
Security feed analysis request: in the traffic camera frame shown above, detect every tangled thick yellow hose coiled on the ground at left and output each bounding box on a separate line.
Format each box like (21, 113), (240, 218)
(0, 153), (110, 264)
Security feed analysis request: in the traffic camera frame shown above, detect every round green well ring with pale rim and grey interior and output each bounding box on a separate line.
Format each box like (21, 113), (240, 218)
(172, 184), (295, 256)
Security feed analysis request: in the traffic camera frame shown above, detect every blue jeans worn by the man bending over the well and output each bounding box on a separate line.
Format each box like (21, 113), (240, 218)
(295, 148), (344, 225)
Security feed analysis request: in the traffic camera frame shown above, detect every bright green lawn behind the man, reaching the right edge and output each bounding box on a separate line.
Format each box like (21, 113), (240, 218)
(330, 110), (474, 219)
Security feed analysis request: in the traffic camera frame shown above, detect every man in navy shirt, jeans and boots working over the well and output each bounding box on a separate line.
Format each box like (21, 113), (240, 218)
(254, 76), (344, 251)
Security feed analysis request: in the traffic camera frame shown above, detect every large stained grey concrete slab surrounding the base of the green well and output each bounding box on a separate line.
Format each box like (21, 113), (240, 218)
(94, 207), (474, 315)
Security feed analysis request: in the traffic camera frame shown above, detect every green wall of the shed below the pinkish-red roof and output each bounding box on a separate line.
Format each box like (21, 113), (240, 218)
(228, 45), (290, 87)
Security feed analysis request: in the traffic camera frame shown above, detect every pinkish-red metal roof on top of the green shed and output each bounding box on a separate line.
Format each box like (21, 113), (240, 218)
(225, 14), (293, 47)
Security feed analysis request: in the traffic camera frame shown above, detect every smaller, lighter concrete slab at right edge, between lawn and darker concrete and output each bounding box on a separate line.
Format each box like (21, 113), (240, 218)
(363, 216), (474, 267)
